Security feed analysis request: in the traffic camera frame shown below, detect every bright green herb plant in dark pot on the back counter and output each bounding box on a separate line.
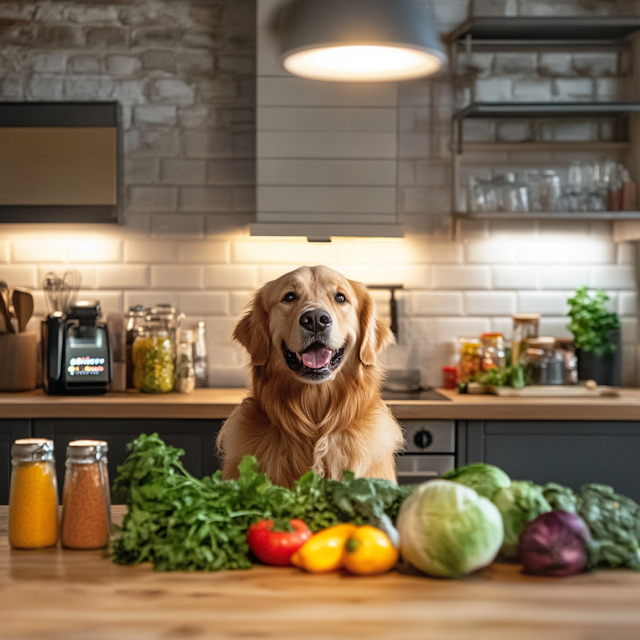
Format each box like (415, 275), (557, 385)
(567, 286), (622, 387)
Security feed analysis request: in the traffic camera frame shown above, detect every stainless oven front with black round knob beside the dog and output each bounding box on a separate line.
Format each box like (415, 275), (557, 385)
(396, 420), (456, 484)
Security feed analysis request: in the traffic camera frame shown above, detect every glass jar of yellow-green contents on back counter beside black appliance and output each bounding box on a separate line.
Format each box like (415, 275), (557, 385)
(131, 328), (173, 393)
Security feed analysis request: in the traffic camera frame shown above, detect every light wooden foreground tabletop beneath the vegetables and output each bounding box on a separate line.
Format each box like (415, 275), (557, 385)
(0, 507), (640, 640)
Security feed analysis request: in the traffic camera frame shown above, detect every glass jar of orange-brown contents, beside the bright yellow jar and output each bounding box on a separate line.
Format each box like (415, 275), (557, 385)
(60, 440), (111, 549)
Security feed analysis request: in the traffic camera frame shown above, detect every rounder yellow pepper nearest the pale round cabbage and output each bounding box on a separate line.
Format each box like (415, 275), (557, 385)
(342, 525), (398, 576)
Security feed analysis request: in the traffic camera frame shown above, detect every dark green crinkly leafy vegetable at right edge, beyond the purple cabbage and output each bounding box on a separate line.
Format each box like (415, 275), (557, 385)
(577, 484), (640, 570)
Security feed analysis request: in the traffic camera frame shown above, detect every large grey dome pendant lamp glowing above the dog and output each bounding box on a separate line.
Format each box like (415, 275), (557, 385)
(280, 0), (446, 82)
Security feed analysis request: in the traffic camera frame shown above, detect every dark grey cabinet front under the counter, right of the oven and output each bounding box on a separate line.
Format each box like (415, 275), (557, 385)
(456, 420), (640, 502)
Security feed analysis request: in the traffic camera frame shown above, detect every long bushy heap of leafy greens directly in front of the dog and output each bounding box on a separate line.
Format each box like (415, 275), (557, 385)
(112, 434), (413, 571)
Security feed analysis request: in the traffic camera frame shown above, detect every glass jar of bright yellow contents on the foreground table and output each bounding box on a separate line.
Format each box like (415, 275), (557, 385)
(9, 438), (58, 549)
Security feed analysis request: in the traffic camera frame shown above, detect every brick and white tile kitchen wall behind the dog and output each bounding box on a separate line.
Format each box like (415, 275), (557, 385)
(0, 0), (637, 386)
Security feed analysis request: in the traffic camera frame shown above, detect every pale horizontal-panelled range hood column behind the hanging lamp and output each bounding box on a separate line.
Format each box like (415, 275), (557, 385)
(252, 0), (401, 238)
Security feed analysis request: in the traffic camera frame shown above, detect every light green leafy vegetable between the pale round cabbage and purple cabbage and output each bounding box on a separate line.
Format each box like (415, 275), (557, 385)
(492, 480), (551, 559)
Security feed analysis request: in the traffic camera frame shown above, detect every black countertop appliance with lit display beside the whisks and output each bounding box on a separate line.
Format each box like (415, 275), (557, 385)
(42, 302), (112, 395)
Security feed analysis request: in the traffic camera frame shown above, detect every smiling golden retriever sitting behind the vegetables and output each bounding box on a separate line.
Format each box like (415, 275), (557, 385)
(217, 266), (403, 486)
